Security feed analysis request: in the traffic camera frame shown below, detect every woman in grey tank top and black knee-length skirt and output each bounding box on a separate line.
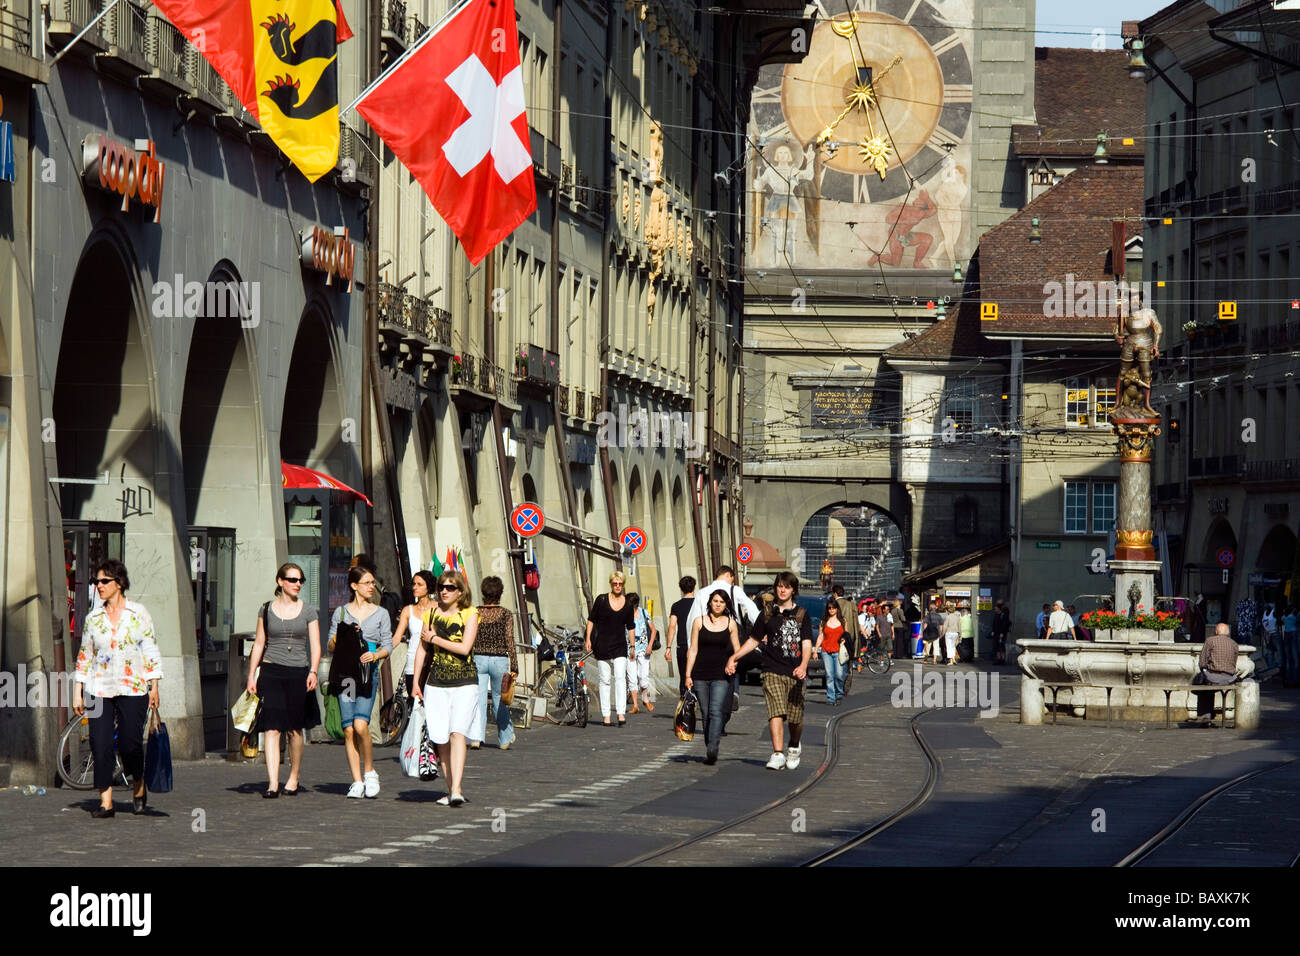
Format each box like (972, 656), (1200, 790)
(248, 563), (321, 797)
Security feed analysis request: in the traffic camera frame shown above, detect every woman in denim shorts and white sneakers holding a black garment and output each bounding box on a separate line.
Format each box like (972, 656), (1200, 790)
(329, 566), (393, 800)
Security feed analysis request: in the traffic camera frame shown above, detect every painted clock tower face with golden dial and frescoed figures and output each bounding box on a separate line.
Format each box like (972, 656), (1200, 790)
(749, 0), (972, 273)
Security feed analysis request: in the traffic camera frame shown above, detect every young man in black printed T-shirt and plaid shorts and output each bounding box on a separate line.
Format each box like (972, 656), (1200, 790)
(727, 571), (813, 770)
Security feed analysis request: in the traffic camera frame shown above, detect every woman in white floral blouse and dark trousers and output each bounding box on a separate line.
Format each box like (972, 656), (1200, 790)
(73, 559), (163, 819)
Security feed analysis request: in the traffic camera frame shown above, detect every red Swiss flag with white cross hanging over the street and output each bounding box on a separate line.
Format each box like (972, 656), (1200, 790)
(356, 0), (537, 264)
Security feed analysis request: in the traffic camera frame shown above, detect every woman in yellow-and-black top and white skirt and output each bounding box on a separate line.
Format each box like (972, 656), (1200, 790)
(412, 571), (484, 806)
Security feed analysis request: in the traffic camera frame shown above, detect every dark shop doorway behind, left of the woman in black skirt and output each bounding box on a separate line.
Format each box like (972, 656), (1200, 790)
(190, 528), (235, 750)
